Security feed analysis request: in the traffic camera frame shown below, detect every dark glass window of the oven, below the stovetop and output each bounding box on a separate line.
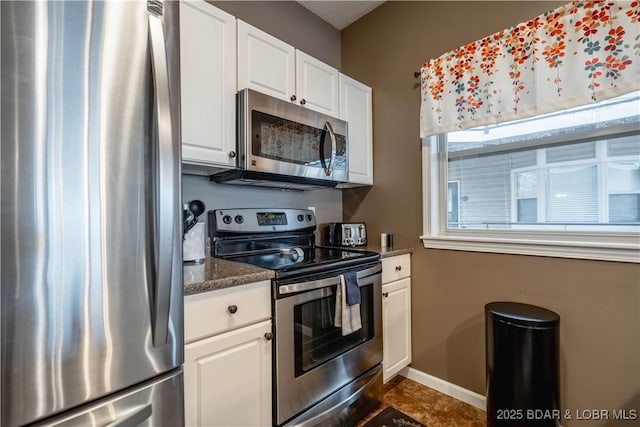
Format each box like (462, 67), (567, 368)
(294, 285), (374, 377)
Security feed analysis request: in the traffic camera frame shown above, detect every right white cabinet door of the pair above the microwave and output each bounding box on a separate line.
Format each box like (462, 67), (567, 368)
(296, 50), (340, 117)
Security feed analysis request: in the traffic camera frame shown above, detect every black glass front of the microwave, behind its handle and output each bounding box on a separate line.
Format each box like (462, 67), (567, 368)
(251, 110), (346, 169)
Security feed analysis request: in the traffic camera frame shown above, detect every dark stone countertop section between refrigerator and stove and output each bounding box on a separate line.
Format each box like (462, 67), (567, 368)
(183, 257), (275, 296)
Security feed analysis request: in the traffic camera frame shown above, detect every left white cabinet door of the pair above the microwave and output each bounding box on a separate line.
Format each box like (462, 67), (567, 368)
(238, 19), (295, 101)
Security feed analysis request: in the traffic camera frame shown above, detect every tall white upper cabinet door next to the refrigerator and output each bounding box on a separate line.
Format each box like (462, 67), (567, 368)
(180, 1), (236, 167)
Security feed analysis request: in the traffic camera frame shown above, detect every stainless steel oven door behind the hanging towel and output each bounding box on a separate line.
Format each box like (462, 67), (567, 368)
(275, 263), (382, 425)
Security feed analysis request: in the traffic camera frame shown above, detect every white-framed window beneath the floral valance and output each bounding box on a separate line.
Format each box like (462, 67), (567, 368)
(423, 92), (640, 262)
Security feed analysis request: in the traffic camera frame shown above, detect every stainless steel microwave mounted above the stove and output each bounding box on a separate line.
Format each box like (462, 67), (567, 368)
(211, 89), (349, 189)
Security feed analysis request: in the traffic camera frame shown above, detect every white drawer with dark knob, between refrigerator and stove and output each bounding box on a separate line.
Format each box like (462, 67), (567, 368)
(184, 280), (271, 343)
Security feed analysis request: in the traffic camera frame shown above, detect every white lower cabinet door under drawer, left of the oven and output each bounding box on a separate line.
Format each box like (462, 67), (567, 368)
(184, 320), (272, 427)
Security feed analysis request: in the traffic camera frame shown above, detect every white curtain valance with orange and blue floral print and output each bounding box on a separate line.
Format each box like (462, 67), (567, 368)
(420, 0), (640, 137)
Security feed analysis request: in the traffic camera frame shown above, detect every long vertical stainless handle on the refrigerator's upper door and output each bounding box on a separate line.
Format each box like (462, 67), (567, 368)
(149, 13), (177, 347)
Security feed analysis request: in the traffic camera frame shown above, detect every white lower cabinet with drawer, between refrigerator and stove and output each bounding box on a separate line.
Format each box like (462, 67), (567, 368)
(184, 281), (273, 427)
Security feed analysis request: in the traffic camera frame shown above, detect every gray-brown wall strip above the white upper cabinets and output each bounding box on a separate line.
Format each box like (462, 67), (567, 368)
(209, 1), (340, 70)
